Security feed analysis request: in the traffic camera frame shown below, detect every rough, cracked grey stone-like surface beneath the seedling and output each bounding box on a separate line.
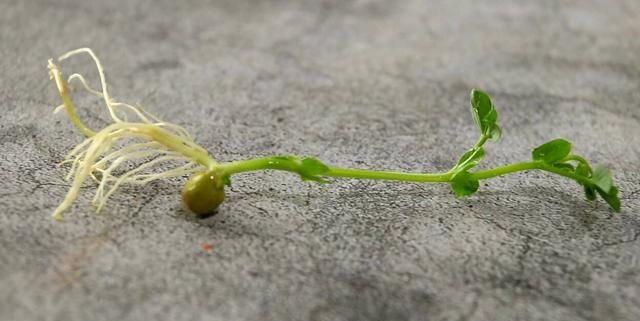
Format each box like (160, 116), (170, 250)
(0, 0), (640, 320)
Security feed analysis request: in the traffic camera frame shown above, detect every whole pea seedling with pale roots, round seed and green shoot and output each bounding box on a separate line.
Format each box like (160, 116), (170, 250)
(48, 48), (620, 220)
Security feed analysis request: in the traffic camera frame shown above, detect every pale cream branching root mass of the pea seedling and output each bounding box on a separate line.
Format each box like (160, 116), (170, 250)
(50, 48), (216, 220)
